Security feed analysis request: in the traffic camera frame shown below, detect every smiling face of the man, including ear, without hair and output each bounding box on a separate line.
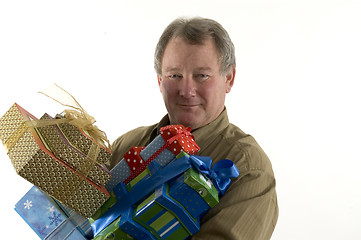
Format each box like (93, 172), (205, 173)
(158, 37), (235, 129)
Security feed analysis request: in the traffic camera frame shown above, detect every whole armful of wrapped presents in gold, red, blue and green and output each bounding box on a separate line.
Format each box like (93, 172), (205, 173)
(0, 104), (238, 240)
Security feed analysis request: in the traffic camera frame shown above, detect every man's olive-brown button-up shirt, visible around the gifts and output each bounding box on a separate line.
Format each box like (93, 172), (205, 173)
(110, 109), (278, 240)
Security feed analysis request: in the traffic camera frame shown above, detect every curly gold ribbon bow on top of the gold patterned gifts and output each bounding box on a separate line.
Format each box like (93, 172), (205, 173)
(39, 84), (111, 149)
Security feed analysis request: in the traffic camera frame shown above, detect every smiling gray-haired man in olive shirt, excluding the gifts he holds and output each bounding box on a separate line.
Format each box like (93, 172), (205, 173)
(110, 18), (278, 240)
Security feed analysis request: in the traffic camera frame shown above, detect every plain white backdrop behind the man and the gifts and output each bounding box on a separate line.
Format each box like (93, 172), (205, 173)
(0, 0), (361, 240)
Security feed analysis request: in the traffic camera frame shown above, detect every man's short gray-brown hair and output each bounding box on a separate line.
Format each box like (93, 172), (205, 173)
(154, 17), (236, 75)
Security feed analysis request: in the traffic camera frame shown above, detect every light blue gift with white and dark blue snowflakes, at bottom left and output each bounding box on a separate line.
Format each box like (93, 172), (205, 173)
(15, 186), (86, 240)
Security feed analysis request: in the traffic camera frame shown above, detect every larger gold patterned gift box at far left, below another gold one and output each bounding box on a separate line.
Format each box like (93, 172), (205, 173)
(0, 103), (109, 217)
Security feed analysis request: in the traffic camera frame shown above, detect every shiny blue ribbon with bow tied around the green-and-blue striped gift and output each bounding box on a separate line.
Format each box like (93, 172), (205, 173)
(91, 155), (239, 236)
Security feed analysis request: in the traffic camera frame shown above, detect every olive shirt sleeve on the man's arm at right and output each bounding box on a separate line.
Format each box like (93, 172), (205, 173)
(192, 144), (278, 240)
